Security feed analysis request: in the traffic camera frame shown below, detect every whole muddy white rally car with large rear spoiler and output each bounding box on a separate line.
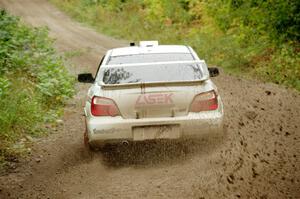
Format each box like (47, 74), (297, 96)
(78, 41), (224, 148)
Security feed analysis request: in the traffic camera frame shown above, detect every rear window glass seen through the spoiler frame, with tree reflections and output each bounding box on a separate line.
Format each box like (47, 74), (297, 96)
(101, 62), (203, 84)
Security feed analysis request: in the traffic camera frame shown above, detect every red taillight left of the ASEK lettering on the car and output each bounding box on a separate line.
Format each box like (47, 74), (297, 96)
(91, 96), (120, 117)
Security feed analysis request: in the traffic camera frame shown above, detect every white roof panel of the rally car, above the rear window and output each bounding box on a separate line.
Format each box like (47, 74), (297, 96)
(110, 45), (191, 56)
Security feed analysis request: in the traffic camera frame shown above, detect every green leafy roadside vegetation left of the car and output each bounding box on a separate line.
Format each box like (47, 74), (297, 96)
(0, 10), (74, 169)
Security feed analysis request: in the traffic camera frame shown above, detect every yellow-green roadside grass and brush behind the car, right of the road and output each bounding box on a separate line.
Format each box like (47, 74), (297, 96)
(49, 0), (300, 91)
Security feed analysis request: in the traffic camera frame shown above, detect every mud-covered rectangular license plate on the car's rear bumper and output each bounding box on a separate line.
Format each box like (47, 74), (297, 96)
(133, 125), (180, 141)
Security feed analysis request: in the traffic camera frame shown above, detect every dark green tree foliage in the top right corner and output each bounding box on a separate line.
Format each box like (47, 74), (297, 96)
(207, 0), (300, 42)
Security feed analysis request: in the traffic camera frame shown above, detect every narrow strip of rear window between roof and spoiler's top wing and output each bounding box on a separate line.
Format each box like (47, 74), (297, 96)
(107, 53), (194, 65)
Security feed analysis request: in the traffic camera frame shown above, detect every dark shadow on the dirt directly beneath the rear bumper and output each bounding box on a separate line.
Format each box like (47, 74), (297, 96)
(101, 132), (225, 168)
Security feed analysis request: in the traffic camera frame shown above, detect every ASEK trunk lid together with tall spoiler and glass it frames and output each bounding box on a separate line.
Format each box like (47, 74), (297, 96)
(100, 61), (207, 119)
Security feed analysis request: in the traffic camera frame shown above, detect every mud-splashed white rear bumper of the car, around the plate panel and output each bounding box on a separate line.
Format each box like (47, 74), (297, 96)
(87, 110), (223, 145)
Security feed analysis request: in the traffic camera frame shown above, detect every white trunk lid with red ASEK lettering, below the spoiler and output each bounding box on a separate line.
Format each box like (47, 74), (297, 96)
(103, 84), (207, 119)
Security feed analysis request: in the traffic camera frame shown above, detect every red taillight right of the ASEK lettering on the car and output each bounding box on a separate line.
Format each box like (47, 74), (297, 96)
(190, 91), (218, 112)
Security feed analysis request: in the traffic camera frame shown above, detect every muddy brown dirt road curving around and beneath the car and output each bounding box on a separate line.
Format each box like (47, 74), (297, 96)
(0, 0), (300, 199)
